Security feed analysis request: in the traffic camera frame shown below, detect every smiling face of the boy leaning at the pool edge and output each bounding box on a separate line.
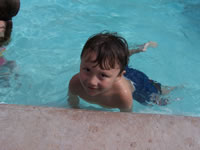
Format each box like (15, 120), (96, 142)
(79, 54), (121, 96)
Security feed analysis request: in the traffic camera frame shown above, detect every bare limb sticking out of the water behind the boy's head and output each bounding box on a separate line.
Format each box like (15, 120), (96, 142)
(129, 41), (157, 56)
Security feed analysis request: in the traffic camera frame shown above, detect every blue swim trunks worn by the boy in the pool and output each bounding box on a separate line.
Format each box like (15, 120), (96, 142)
(124, 66), (162, 105)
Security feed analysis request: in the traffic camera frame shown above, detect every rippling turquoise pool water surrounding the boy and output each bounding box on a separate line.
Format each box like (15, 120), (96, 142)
(0, 0), (200, 116)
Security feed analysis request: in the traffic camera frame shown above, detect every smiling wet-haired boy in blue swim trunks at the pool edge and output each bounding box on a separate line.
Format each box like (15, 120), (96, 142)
(68, 33), (171, 112)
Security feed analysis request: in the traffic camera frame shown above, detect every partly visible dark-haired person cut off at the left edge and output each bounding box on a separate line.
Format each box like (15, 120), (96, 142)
(0, 0), (20, 83)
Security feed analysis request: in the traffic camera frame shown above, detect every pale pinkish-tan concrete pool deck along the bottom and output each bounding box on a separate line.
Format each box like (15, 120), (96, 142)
(0, 104), (200, 150)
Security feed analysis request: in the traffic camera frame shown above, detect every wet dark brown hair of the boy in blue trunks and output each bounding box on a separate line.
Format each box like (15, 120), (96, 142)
(81, 32), (129, 73)
